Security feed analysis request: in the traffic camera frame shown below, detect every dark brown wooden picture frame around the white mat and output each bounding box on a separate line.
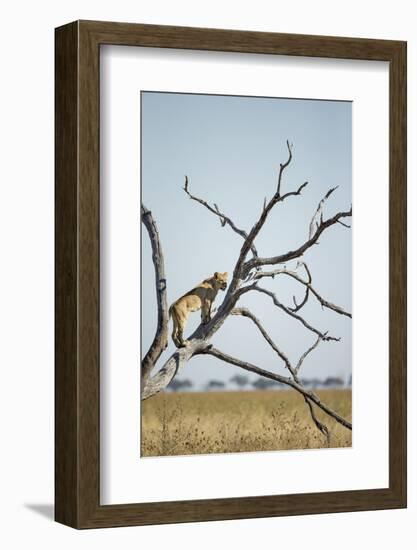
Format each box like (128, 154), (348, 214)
(55, 21), (406, 528)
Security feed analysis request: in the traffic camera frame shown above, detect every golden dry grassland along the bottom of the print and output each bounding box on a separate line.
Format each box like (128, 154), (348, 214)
(141, 389), (352, 456)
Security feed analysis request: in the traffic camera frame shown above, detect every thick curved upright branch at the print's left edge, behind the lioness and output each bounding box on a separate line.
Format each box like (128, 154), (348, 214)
(141, 204), (168, 379)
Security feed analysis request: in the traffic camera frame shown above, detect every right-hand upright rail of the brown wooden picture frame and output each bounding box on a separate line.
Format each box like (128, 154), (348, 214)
(389, 43), (407, 506)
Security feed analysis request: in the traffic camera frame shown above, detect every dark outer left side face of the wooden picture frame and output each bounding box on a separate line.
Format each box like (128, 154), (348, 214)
(55, 23), (79, 525)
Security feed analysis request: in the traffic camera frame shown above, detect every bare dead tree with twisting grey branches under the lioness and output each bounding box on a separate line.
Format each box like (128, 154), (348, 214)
(141, 141), (352, 440)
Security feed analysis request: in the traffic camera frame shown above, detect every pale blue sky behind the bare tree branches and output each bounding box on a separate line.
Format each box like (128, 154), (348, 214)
(141, 92), (352, 385)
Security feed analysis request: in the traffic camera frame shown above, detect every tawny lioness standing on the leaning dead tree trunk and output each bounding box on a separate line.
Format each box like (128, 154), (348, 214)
(169, 271), (228, 348)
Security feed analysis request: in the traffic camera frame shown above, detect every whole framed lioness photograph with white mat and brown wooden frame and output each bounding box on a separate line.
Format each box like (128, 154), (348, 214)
(55, 21), (406, 528)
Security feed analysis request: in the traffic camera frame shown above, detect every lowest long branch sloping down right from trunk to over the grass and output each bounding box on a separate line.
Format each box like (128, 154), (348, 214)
(200, 347), (352, 430)
